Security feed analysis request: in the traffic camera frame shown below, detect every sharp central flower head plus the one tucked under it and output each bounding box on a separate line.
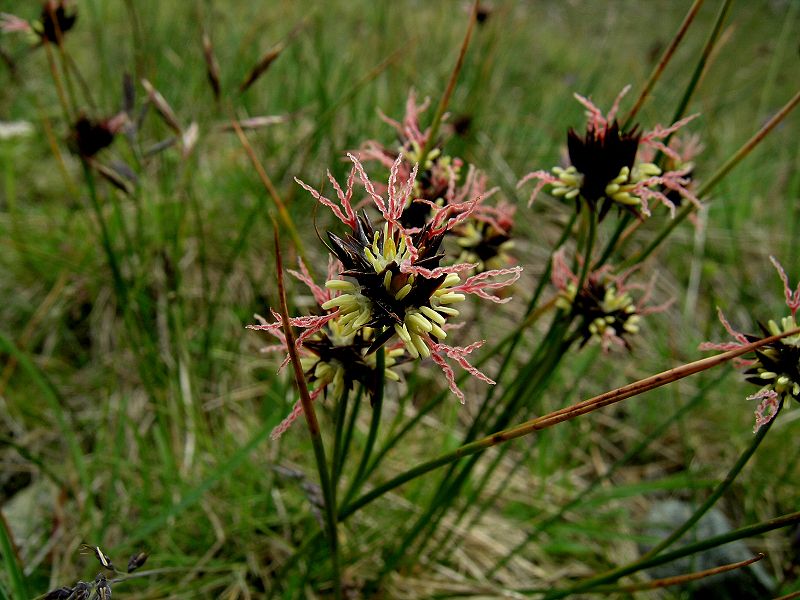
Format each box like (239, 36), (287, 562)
(249, 154), (521, 437)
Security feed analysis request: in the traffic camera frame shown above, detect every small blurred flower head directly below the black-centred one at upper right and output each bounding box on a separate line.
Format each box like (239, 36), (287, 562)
(552, 249), (671, 352)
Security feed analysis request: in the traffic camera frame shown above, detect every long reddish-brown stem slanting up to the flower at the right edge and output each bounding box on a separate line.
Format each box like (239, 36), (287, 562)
(339, 328), (800, 519)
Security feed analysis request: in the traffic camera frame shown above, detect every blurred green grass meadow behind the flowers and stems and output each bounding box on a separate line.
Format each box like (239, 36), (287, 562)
(0, 0), (800, 598)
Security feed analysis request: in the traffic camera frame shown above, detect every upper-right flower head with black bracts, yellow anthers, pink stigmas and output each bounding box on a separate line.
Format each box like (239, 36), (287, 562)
(517, 86), (699, 220)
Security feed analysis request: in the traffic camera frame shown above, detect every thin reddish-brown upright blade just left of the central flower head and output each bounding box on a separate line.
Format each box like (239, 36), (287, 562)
(273, 231), (342, 600)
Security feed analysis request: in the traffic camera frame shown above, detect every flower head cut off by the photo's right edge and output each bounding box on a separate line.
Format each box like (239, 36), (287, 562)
(700, 256), (800, 431)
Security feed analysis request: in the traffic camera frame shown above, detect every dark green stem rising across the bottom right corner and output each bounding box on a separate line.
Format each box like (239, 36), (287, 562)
(545, 512), (800, 600)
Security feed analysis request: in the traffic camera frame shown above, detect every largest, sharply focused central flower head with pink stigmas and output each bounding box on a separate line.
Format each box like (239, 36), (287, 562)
(297, 155), (521, 400)
